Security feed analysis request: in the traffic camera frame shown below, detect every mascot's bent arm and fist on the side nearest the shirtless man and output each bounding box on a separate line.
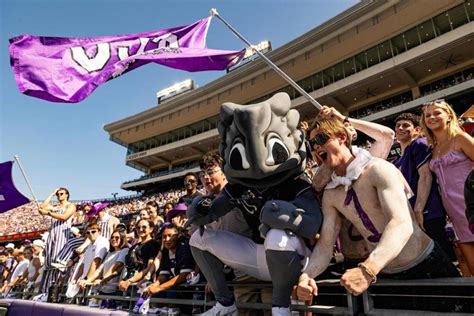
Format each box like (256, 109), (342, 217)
(260, 190), (322, 239)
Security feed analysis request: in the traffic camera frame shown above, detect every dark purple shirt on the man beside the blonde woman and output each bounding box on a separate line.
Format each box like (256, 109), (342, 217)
(393, 137), (446, 220)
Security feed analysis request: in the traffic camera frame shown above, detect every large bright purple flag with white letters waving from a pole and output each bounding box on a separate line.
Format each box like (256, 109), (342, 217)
(9, 17), (245, 103)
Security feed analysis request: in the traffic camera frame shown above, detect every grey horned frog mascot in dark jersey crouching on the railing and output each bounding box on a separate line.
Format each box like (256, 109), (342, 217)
(187, 93), (322, 315)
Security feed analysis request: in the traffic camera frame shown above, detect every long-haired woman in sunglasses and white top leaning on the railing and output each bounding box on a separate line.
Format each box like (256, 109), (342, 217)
(80, 230), (129, 295)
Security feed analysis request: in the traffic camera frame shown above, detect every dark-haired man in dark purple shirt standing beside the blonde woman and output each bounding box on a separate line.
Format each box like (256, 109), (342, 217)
(394, 113), (455, 260)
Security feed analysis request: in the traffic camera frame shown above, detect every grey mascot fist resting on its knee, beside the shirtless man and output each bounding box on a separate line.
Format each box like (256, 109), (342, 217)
(260, 200), (304, 232)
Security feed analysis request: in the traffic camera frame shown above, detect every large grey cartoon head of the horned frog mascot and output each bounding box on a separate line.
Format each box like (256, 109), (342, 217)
(219, 93), (306, 189)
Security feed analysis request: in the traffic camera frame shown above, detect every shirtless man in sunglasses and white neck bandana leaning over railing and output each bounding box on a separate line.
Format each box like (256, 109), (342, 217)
(297, 119), (459, 300)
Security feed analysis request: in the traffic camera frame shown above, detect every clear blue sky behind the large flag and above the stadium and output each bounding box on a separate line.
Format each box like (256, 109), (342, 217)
(0, 0), (357, 199)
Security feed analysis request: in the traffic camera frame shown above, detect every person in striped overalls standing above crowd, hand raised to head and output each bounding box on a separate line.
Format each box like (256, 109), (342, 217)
(39, 188), (76, 293)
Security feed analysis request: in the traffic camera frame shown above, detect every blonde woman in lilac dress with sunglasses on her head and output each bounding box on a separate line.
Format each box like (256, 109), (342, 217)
(421, 100), (474, 276)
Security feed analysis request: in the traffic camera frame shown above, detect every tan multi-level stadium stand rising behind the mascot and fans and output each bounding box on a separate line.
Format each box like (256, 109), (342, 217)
(104, 0), (474, 192)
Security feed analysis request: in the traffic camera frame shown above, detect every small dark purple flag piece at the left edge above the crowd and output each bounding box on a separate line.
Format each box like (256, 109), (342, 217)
(0, 161), (30, 213)
